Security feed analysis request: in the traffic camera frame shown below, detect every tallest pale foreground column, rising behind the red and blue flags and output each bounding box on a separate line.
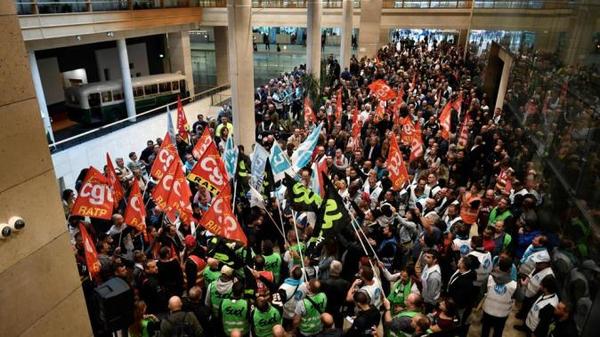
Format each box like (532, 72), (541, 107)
(227, 0), (256, 153)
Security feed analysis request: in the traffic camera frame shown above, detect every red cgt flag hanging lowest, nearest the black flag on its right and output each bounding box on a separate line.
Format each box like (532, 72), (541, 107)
(200, 188), (248, 246)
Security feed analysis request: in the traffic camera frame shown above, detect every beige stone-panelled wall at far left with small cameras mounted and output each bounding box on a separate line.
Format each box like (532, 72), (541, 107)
(0, 1), (92, 337)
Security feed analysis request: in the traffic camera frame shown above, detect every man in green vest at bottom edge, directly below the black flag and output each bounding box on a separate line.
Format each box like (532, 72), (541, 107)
(294, 279), (327, 336)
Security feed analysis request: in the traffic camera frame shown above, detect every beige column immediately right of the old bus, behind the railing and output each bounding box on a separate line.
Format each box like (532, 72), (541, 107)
(167, 31), (195, 96)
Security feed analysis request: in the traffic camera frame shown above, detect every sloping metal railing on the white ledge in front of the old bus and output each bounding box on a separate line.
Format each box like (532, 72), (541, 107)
(48, 84), (231, 153)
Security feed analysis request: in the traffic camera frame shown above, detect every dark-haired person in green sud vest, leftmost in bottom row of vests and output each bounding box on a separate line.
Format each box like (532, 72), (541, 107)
(220, 282), (250, 336)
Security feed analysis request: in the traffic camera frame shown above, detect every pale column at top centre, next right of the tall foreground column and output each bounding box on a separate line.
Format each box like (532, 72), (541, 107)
(306, 0), (322, 81)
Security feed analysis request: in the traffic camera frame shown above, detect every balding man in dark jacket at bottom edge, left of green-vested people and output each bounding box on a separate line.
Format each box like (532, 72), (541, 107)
(160, 296), (204, 337)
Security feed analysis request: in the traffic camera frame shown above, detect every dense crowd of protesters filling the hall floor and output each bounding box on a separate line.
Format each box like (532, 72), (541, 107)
(63, 39), (600, 337)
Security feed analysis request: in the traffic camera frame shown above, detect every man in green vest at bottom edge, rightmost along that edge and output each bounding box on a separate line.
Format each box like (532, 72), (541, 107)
(383, 293), (423, 337)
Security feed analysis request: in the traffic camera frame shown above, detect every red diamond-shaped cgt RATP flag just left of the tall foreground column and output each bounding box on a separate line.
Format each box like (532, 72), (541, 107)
(187, 142), (228, 195)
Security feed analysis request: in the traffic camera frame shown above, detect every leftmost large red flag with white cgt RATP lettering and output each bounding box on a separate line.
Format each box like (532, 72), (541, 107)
(71, 166), (114, 220)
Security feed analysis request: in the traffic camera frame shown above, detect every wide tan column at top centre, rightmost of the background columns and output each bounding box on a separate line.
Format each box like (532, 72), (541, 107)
(358, 0), (382, 58)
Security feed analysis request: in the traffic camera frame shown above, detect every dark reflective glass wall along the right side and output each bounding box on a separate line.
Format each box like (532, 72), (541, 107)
(469, 1), (600, 288)
